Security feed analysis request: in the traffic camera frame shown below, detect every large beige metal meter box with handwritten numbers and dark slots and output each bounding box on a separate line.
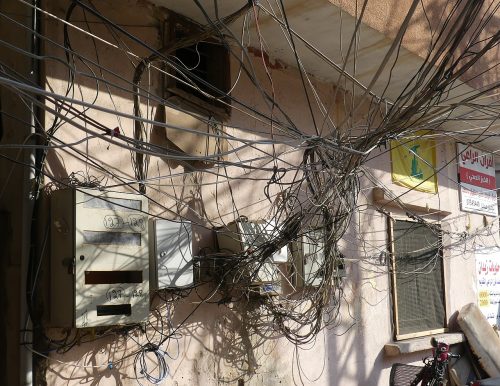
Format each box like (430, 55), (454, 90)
(50, 189), (149, 328)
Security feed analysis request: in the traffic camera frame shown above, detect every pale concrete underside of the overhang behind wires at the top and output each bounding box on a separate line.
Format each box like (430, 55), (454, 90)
(150, 0), (500, 156)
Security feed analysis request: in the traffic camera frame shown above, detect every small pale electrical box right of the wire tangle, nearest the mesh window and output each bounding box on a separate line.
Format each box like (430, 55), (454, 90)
(291, 231), (345, 288)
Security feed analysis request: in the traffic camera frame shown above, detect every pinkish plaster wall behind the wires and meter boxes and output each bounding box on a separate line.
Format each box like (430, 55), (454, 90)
(0, 1), (498, 386)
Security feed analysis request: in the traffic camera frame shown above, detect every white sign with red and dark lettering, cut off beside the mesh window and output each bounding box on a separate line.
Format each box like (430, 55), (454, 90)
(475, 248), (500, 326)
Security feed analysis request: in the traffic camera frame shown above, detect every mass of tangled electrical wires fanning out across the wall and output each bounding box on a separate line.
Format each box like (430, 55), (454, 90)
(0, 1), (498, 383)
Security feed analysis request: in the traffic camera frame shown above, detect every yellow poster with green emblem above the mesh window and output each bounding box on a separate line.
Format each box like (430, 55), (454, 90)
(391, 131), (437, 193)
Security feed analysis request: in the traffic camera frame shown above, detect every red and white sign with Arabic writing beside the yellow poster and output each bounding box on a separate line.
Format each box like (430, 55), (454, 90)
(458, 144), (498, 216)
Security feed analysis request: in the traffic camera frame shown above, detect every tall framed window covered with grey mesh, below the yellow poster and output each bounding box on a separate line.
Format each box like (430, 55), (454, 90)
(390, 220), (446, 339)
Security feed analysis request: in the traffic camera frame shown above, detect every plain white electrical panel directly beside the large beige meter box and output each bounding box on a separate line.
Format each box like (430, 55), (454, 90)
(149, 220), (194, 289)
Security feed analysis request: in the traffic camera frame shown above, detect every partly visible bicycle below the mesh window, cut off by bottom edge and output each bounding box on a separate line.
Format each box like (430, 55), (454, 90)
(389, 338), (460, 386)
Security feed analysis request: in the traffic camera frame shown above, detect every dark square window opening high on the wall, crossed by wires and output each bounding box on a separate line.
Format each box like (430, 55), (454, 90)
(166, 15), (231, 121)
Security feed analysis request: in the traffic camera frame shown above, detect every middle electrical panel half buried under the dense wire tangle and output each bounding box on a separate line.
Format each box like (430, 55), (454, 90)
(217, 219), (288, 295)
